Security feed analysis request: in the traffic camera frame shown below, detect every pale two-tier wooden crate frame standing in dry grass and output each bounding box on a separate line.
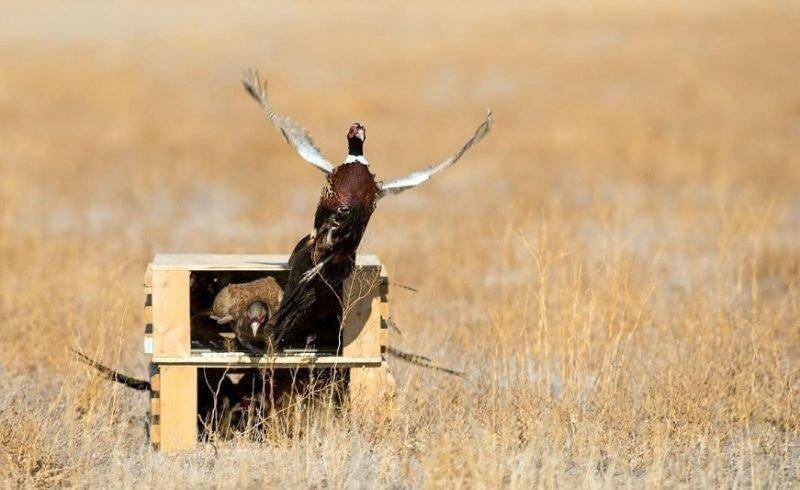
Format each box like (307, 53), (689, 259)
(144, 255), (394, 451)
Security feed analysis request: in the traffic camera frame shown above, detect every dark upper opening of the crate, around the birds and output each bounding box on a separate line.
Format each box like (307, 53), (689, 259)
(189, 270), (342, 355)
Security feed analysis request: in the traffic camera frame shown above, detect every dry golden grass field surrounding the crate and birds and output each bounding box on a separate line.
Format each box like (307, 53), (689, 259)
(0, 1), (800, 488)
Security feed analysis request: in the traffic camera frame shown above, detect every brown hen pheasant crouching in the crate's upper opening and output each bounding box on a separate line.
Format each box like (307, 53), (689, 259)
(209, 277), (283, 353)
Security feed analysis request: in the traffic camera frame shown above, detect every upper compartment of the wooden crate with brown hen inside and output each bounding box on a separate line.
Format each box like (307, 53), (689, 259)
(145, 255), (388, 358)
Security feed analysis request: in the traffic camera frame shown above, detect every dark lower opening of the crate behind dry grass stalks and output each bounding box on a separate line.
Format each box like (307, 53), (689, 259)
(197, 368), (349, 441)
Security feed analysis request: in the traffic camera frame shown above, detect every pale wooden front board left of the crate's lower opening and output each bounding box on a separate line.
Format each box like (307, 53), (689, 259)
(159, 366), (197, 452)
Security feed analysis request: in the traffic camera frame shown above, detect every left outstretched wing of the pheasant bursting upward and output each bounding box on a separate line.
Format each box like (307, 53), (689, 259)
(242, 70), (333, 174)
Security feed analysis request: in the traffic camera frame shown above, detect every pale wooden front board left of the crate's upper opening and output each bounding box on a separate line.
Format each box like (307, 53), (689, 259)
(153, 269), (191, 356)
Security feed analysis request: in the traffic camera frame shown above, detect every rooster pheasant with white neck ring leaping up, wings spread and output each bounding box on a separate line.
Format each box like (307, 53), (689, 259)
(243, 71), (493, 343)
